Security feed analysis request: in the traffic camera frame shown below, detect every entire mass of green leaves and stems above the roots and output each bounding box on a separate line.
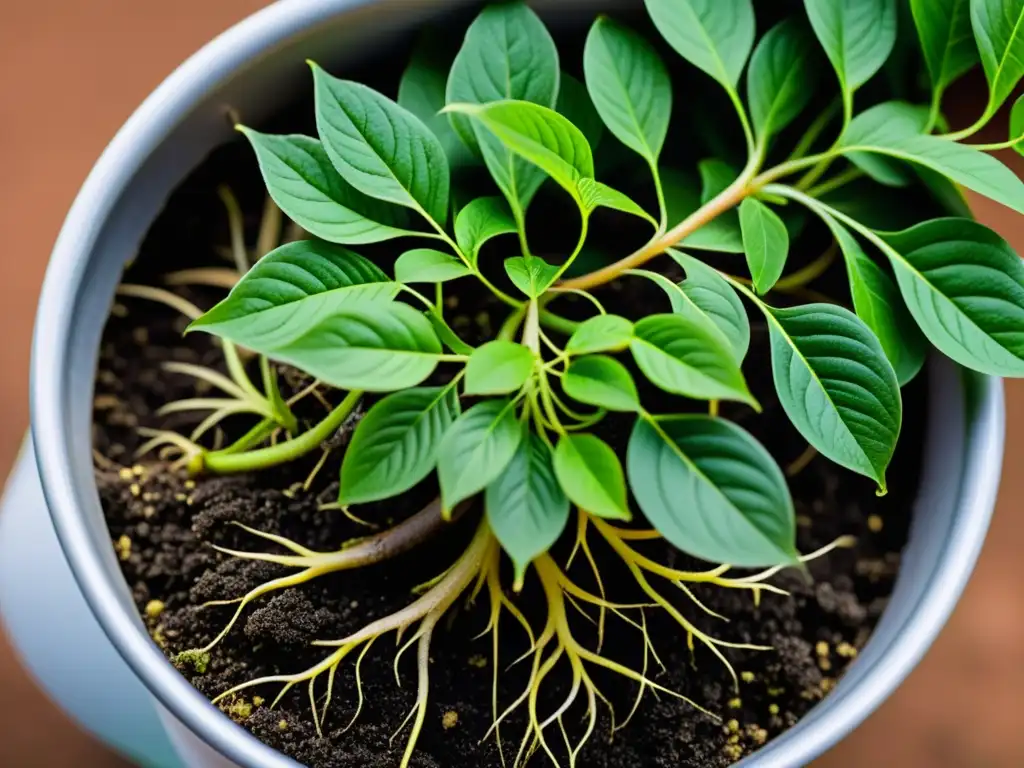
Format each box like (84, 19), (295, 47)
(190, 0), (1024, 582)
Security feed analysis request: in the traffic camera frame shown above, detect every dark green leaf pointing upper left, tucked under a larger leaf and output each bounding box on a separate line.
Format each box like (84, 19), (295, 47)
(239, 128), (411, 245)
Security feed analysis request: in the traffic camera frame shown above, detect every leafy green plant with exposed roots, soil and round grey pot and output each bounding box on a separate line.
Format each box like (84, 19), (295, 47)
(19, 0), (1024, 767)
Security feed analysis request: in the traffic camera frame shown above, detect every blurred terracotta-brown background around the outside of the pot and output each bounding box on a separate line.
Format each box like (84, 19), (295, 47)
(0, 0), (1024, 768)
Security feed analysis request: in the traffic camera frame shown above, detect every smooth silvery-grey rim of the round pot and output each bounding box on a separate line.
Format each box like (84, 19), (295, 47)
(31, 0), (1005, 768)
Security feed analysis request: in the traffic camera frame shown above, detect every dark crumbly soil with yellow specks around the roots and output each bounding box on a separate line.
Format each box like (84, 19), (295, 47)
(94, 15), (927, 768)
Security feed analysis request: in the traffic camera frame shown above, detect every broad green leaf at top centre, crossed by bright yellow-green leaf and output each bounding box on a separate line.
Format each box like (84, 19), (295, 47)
(445, 2), (560, 212)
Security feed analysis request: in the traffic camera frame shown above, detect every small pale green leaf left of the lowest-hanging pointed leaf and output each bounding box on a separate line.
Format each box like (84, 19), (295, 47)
(437, 399), (523, 513)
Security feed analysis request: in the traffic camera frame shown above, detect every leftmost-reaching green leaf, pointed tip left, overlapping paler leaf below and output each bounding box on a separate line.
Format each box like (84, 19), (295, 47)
(188, 240), (398, 352)
